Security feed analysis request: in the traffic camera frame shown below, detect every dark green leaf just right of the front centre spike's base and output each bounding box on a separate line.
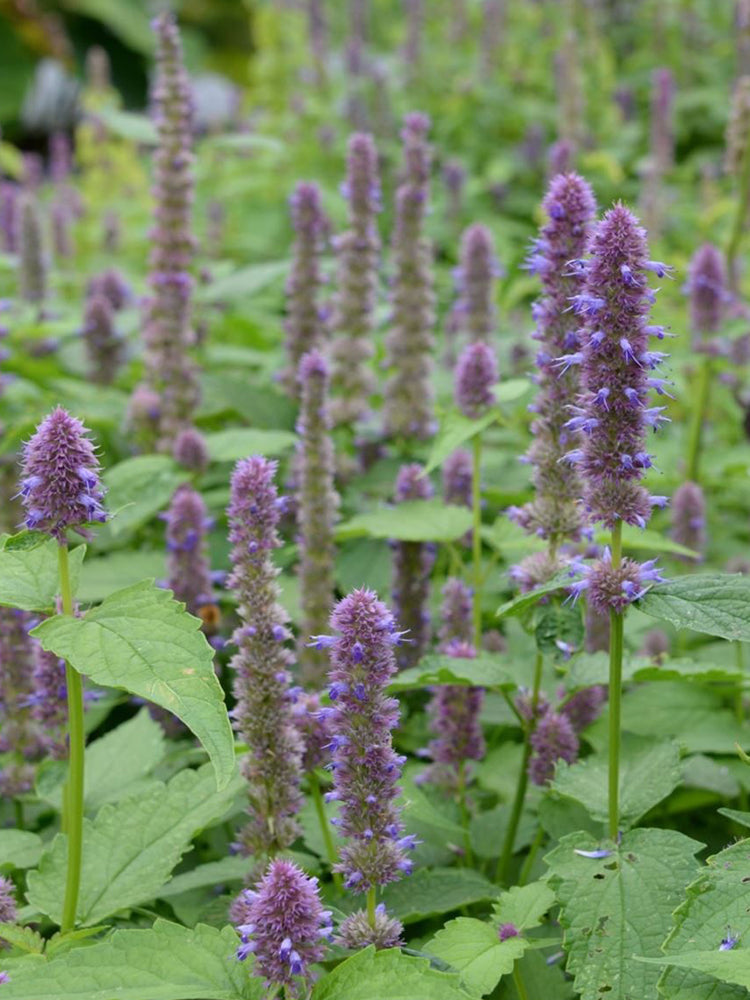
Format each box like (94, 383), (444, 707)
(382, 868), (499, 924)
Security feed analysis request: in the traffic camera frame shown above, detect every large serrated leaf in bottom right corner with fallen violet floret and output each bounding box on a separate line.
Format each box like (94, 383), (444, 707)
(655, 840), (750, 1000)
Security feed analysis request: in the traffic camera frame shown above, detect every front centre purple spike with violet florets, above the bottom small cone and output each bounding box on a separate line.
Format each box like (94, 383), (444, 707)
(329, 590), (411, 892)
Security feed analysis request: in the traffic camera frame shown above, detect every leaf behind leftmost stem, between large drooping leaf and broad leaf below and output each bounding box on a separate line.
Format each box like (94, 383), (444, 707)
(37, 708), (166, 812)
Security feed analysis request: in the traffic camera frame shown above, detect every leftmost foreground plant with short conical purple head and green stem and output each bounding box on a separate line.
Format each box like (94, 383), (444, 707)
(20, 407), (107, 933)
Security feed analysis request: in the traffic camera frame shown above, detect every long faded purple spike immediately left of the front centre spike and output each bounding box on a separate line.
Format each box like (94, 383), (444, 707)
(227, 456), (302, 855)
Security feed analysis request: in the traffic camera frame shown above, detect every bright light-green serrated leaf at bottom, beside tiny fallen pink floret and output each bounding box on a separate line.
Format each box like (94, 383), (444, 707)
(425, 917), (527, 996)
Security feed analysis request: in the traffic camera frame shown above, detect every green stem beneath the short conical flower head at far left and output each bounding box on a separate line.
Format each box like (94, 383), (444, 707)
(57, 545), (86, 934)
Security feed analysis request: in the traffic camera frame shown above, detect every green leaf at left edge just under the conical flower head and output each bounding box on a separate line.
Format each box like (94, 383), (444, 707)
(0, 532), (86, 611)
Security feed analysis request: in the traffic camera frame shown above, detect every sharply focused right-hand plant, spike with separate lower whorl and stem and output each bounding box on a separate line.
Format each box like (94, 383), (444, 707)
(567, 204), (668, 840)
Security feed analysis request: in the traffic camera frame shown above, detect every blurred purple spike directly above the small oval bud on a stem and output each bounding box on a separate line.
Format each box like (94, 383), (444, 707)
(455, 223), (500, 343)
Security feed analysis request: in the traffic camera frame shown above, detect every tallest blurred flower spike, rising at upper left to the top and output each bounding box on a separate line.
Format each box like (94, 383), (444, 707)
(133, 13), (200, 452)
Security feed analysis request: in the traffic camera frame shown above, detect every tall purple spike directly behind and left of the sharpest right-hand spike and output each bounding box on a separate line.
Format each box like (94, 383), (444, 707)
(509, 174), (596, 548)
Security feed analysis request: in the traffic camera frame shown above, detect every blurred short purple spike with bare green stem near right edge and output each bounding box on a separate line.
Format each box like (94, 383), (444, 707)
(685, 248), (728, 483)
